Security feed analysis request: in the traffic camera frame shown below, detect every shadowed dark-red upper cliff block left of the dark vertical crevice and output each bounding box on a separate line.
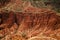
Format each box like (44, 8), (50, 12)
(1, 12), (14, 25)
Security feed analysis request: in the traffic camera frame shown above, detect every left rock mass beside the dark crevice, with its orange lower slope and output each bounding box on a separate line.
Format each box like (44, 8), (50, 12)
(0, 12), (15, 37)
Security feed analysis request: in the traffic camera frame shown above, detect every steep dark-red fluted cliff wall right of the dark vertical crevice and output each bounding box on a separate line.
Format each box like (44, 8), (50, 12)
(16, 13), (58, 28)
